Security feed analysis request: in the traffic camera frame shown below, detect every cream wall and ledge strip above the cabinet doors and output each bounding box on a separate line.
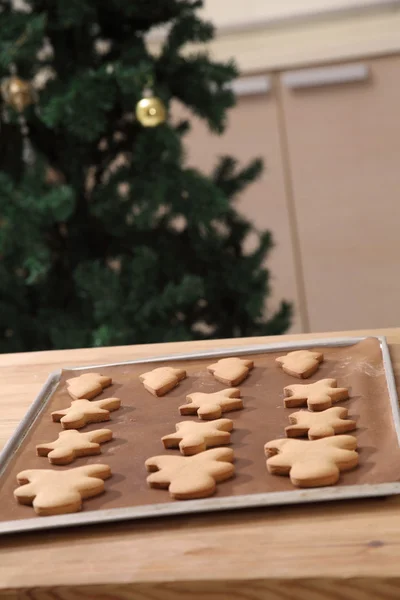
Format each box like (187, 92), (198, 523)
(148, 0), (400, 74)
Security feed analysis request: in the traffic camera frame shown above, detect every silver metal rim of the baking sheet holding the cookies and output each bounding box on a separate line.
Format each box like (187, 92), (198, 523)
(0, 336), (400, 534)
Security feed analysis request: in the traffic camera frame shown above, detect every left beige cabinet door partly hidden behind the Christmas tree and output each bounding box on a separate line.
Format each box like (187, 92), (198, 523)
(173, 77), (303, 332)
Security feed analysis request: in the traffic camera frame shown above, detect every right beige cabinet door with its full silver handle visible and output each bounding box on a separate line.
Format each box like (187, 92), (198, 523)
(281, 56), (400, 331)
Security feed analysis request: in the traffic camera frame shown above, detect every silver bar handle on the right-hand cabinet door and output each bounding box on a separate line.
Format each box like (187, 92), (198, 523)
(282, 63), (369, 90)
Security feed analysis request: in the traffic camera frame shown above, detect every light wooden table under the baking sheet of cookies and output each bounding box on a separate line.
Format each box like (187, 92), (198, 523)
(0, 329), (400, 600)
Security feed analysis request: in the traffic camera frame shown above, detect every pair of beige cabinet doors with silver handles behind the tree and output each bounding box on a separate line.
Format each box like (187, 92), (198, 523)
(178, 55), (400, 332)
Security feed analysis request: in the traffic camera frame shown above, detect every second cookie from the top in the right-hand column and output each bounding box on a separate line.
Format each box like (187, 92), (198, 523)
(283, 379), (349, 411)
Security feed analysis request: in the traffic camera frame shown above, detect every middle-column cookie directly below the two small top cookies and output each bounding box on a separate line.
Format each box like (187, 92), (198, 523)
(179, 388), (243, 420)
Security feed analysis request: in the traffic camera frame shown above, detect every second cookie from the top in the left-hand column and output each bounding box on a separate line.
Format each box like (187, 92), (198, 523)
(51, 398), (121, 429)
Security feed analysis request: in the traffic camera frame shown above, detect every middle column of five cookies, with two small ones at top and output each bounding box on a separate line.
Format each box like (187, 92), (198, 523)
(140, 357), (254, 500)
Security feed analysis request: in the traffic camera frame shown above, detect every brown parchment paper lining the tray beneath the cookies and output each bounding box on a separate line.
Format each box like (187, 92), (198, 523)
(0, 338), (400, 521)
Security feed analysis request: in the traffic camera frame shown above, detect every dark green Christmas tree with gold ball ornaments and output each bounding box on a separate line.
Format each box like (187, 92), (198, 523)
(0, 0), (291, 352)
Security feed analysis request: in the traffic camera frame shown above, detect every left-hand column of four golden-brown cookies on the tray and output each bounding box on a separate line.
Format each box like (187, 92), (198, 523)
(14, 373), (121, 516)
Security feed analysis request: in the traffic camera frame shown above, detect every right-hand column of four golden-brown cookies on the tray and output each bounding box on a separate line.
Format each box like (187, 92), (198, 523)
(264, 350), (358, 487)
